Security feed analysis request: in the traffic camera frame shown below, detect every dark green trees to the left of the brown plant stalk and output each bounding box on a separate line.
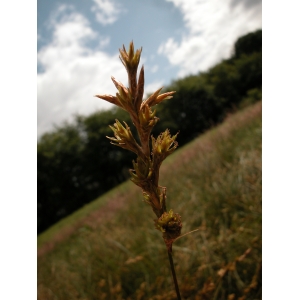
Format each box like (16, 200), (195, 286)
(37, 109), (133, 233)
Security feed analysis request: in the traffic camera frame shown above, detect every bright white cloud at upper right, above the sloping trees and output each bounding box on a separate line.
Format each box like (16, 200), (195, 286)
(158, 0), (262, 76)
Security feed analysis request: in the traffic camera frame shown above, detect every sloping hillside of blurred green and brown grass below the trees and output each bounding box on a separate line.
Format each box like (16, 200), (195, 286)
(38, 102), (262, 300)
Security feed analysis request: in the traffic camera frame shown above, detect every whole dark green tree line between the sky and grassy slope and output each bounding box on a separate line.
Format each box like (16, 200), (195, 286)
(37, 30), (262, 234)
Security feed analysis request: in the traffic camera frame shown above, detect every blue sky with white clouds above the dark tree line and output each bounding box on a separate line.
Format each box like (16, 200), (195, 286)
(37, 0), (262, 137)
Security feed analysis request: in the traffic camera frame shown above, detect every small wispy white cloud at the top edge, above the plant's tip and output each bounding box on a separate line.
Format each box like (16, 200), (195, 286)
(92, 0), (121, 25)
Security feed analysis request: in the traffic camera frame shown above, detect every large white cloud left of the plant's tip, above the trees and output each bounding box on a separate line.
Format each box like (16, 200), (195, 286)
(37, 7), (127, 136)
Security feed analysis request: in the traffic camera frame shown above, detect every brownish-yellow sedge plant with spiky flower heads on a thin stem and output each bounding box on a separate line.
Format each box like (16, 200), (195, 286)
(96, 42), (182, 299)
